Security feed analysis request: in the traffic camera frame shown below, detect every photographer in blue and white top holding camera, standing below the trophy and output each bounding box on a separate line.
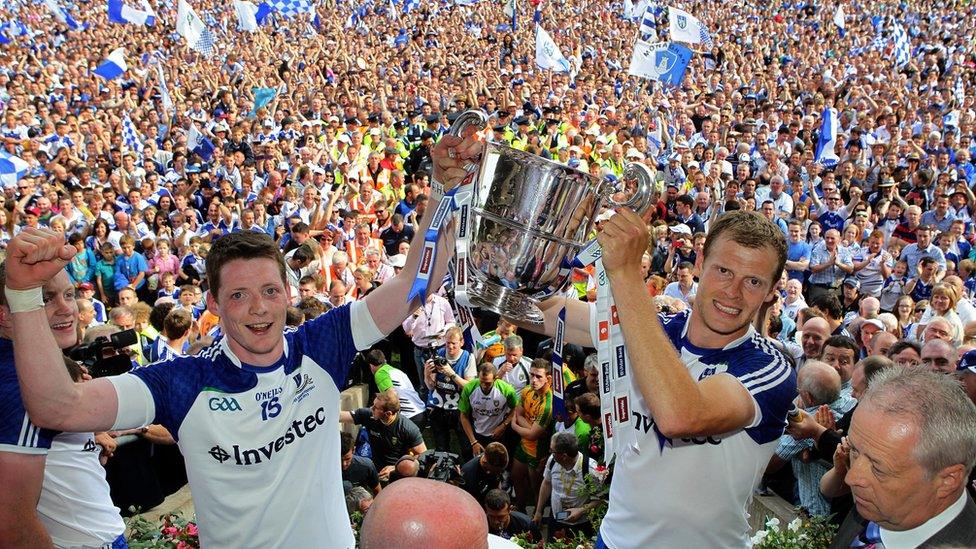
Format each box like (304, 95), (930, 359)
(424, 326), (477, 459)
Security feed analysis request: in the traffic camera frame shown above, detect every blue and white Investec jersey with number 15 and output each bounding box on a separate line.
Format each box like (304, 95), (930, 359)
(109, 302), (375, 548)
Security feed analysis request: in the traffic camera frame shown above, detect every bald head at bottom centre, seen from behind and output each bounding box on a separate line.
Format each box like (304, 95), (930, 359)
(359, 478), (488, 549)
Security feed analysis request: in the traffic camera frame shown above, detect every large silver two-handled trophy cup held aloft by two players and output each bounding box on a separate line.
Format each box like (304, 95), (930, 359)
(450, 111), (653, 324)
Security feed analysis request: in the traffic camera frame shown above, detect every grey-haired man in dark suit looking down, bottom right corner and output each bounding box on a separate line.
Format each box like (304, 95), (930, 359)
(831, 367), (976, 549)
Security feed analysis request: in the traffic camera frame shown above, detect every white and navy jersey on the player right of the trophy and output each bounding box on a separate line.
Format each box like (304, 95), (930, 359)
(590, 309), (797, 549)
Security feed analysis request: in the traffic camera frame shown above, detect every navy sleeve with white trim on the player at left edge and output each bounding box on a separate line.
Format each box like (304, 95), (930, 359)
(0, 338), (57, 455)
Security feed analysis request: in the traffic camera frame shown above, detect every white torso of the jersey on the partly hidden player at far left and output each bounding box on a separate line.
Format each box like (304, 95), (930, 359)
(37, 433), (125, 547)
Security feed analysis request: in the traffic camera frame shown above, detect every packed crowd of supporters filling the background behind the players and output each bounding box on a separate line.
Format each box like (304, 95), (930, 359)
(0, 0), (976, 536)
